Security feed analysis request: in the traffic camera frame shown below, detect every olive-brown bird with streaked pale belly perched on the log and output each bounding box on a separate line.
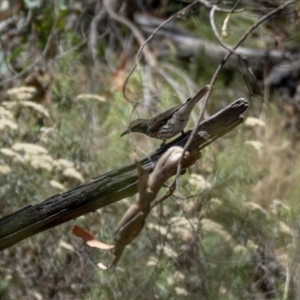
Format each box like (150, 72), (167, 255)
(120, 85), (210, 147)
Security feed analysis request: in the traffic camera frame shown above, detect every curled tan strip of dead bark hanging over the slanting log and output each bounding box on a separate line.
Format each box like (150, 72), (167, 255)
(99, 146), (201, 270)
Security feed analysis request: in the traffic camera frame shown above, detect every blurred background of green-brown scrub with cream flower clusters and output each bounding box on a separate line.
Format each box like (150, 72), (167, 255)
(0, 0), (300, 300)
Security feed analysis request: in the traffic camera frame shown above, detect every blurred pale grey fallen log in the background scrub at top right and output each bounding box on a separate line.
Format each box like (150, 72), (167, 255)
(135, 14), (291, 70)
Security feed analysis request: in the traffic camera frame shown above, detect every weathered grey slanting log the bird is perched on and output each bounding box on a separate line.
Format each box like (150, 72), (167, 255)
(0, 99), (248, 250)
